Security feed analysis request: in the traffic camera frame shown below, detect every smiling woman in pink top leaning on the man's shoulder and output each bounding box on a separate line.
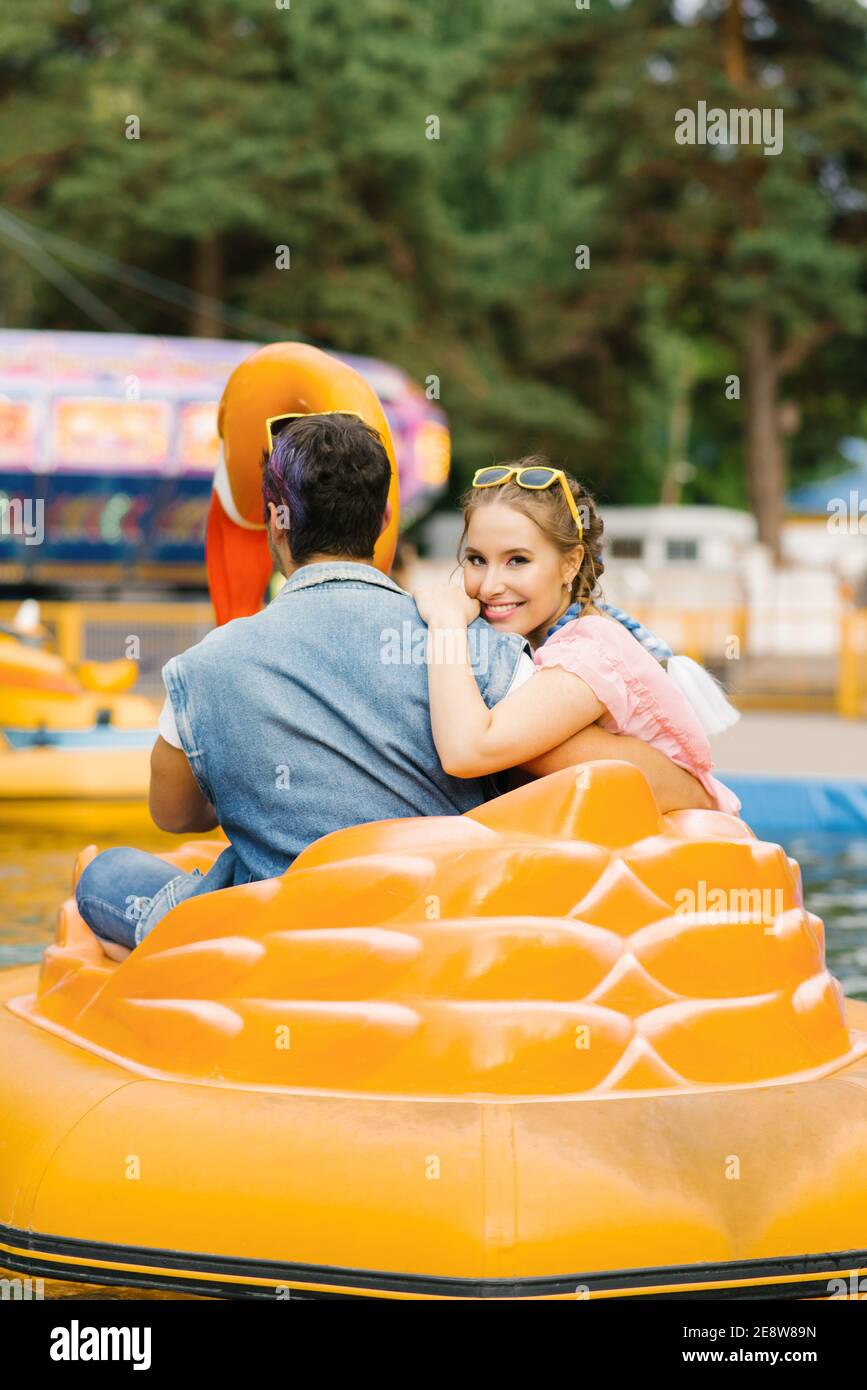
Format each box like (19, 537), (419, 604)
(415, 456), (741, 812)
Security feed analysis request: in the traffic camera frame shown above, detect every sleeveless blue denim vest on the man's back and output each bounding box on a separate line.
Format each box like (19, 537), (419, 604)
(138, 562), (532, 940)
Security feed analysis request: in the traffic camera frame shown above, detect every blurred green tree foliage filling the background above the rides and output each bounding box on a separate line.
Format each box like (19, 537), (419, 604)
(0, 0), (867, 541)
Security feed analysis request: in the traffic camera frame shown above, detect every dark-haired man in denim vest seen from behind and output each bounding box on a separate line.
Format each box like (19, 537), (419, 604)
(76, 413), (705, 959)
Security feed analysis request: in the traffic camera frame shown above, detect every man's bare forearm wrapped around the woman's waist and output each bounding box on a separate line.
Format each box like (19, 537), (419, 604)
(520, 724), (714, 813)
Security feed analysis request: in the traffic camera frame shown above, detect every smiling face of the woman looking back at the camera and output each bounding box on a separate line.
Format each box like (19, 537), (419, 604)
(464, 502), (584, 641)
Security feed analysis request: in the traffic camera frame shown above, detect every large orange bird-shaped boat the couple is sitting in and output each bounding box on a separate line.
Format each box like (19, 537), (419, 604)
(0, 341), (867, 1298)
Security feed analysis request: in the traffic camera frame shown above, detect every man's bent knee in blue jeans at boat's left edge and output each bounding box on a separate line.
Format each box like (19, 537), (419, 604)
(75, 849), (201, 948)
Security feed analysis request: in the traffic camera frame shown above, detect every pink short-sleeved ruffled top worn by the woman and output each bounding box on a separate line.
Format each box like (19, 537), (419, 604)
(534, 613), (741, 816)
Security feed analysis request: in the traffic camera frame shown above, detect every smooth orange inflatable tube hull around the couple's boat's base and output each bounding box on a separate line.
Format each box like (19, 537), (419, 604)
(0, 967), (867, 1300)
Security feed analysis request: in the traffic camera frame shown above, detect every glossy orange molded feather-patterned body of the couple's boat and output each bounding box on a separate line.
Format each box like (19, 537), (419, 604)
(10, 763), (867, 1098)
